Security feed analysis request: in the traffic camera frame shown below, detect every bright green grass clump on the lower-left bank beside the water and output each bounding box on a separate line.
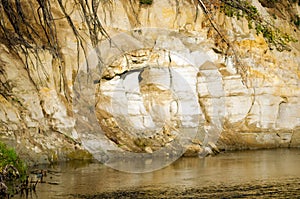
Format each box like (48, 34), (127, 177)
(0, 142), (27, 178)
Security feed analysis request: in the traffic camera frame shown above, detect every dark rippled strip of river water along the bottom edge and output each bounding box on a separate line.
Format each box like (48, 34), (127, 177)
(67, 178), (300, 199)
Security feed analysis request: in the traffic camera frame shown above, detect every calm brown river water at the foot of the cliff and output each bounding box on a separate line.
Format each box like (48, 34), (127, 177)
(29, 149), (300, 199)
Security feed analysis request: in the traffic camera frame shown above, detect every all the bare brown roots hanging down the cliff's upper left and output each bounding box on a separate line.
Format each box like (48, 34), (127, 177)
(0, 0), (110, 102)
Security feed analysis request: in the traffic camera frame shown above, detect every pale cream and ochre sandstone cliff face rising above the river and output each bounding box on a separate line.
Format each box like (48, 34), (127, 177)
(0, 0), (300, 162)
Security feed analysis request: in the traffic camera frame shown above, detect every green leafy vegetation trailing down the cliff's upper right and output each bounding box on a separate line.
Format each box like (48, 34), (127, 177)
(221, 0), (300, 51)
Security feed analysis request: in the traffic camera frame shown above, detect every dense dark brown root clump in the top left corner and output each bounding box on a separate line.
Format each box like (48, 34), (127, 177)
(0, 0), (48, 90)
